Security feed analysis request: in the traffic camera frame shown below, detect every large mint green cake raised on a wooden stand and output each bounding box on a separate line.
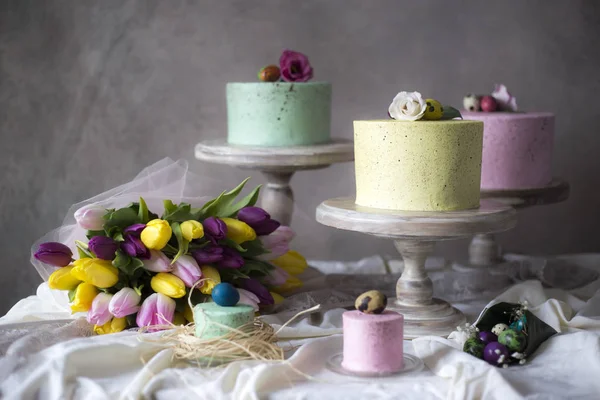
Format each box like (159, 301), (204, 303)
(227, 82), (331, 147)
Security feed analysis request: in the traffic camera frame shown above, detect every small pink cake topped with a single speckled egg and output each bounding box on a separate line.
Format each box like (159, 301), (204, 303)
(342, 310), (404, 373)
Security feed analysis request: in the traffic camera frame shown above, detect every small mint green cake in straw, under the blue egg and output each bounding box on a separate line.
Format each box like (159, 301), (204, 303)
(194, 303), (254, 339)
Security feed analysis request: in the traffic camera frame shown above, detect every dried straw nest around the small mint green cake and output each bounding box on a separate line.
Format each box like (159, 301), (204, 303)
(142, 282), (320, 367)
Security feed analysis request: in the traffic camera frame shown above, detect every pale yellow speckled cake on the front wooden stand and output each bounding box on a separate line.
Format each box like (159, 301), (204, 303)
(354, 119), (483, 211)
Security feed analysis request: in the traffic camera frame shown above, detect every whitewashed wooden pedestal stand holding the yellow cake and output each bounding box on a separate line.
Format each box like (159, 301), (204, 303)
(317, 198), (516, 339)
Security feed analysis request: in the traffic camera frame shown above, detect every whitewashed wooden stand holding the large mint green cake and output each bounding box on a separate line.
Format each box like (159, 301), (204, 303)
(196, 139), (354, 225)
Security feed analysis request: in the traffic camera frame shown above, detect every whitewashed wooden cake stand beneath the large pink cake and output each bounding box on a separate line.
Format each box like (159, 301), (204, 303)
(453, 178), (569, 276)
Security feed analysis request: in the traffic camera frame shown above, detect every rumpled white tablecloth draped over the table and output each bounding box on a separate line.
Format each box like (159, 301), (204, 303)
(0, 255), (600, 400)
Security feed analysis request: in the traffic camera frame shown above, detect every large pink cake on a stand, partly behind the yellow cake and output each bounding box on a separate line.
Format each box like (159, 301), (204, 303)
(461, 111), (554, 189)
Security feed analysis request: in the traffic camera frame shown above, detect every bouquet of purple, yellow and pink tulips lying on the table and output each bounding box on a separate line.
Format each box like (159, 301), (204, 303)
(34, 179), (307, 334)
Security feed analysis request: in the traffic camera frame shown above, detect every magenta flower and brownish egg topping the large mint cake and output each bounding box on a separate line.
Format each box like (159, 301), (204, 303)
(258, 50), (313, 82)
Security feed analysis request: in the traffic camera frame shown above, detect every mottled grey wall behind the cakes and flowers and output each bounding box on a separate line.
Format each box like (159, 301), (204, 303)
(0, 0), (600, 314)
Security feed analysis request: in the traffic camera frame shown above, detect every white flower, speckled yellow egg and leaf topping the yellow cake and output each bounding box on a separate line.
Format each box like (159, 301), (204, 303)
(388, 92), (462, 121)
